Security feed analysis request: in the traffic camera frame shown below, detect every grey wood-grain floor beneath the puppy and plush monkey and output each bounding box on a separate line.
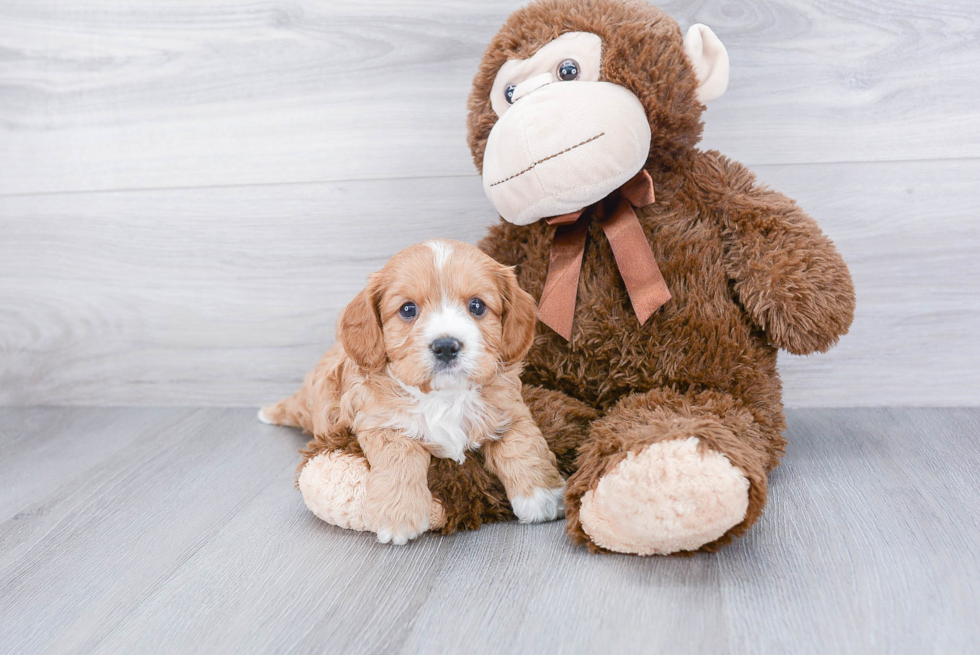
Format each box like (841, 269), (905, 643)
(0, 408), (980, 653)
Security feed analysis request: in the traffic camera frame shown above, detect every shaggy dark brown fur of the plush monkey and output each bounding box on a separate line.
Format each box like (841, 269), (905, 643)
(296, 0), (854, 550)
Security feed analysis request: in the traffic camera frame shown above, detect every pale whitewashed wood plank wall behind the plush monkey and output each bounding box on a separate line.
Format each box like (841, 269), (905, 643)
(0, 0), (980, 406)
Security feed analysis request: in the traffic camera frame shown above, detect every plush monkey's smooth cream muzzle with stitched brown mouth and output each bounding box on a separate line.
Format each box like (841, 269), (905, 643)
(483, 76), (650, 225)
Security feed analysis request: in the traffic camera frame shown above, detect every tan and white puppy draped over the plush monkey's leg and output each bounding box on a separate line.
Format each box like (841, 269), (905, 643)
(259, 240), (565, 544)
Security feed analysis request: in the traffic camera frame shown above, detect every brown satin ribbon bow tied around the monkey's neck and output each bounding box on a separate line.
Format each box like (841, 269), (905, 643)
(538, 171), (670, 340)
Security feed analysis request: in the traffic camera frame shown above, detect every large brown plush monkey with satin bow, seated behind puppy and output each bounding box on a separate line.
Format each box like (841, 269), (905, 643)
(300, 0), (854, 555)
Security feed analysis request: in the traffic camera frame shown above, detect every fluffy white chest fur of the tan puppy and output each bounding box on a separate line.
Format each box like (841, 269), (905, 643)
(387, 383), (487, 464)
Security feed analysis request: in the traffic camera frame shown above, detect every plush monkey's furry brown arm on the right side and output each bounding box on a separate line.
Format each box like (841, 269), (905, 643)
(705, 153), (854, 355)
